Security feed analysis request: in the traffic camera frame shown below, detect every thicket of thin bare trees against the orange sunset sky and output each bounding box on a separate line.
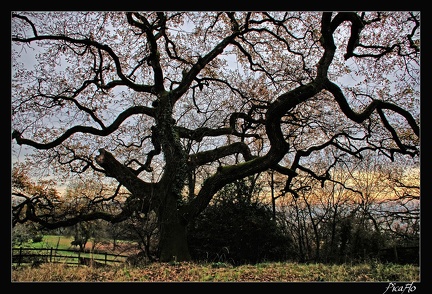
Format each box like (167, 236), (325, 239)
(279, 153), (420, 262)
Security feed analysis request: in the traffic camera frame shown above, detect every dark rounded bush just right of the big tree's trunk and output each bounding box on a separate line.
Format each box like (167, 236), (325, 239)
(188, 201), (292, 264)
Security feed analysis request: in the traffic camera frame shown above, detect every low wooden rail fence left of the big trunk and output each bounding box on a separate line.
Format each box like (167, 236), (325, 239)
(12, 247), (128, 266)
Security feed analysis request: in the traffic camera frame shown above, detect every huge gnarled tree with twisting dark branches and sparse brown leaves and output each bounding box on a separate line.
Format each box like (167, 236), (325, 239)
(11, 11), (420, 261)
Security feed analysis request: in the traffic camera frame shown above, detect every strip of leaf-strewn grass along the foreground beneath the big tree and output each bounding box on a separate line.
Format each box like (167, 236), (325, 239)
(12, 263), (420, 282)
